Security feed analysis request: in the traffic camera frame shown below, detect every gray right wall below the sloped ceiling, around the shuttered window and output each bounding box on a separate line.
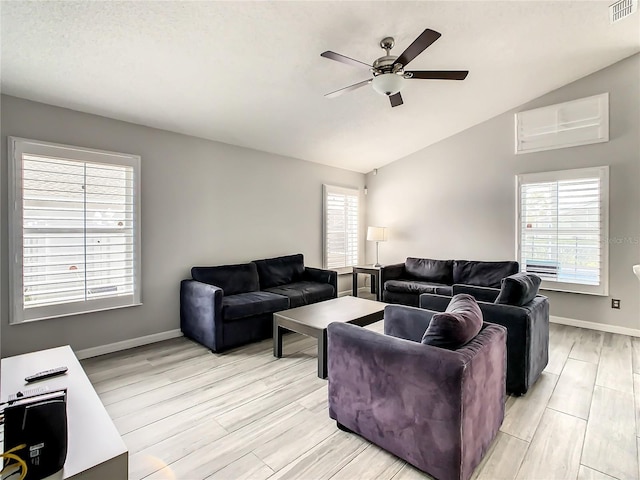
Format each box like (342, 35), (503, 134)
(367, 54), (640, 329)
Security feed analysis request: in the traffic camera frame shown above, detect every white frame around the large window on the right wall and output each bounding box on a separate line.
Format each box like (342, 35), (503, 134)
(515, 166), (610, 296)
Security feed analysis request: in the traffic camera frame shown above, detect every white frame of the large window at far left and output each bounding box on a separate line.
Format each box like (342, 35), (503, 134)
(7, 136), (142, 325)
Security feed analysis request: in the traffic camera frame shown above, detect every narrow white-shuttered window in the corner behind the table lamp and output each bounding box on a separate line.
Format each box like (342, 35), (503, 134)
(323, 185), (360, 272)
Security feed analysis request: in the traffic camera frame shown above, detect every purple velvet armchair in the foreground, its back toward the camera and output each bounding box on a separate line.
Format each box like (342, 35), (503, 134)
(328, 306), (506, 480)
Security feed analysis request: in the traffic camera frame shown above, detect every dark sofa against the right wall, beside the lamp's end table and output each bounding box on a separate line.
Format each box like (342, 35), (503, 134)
(380, 257), (519, 307)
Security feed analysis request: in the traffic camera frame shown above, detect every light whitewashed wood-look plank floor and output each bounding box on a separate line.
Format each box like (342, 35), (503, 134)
(82, 316), (640, 480)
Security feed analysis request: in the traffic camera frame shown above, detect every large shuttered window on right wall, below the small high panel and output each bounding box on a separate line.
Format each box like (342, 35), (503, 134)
(517, 167), (609, 295)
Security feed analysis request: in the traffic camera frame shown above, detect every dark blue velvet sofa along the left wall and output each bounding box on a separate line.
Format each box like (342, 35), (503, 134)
(180, 254), (338, 352)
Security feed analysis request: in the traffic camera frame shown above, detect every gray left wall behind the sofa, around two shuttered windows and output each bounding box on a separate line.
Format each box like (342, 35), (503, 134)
(0, 96), (364, 356)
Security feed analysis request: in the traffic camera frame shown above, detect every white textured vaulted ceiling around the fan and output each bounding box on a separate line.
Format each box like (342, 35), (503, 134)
(0, 0), (640, 172)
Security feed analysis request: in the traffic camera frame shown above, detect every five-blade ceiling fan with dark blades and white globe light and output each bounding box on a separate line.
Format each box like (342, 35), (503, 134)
(320, 28), (469, 107)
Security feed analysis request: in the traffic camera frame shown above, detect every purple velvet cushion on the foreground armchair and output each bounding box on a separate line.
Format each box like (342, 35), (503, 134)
(422, 293), (482, 350)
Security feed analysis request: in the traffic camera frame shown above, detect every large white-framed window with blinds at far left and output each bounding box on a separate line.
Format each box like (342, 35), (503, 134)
(9, 137), (140, 323)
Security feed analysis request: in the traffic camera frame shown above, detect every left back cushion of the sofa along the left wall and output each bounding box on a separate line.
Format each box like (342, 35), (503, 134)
(191, 263), (260, 295)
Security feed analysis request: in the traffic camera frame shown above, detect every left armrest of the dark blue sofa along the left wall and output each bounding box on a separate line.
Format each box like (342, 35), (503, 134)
(180, 280), (223, 352)
